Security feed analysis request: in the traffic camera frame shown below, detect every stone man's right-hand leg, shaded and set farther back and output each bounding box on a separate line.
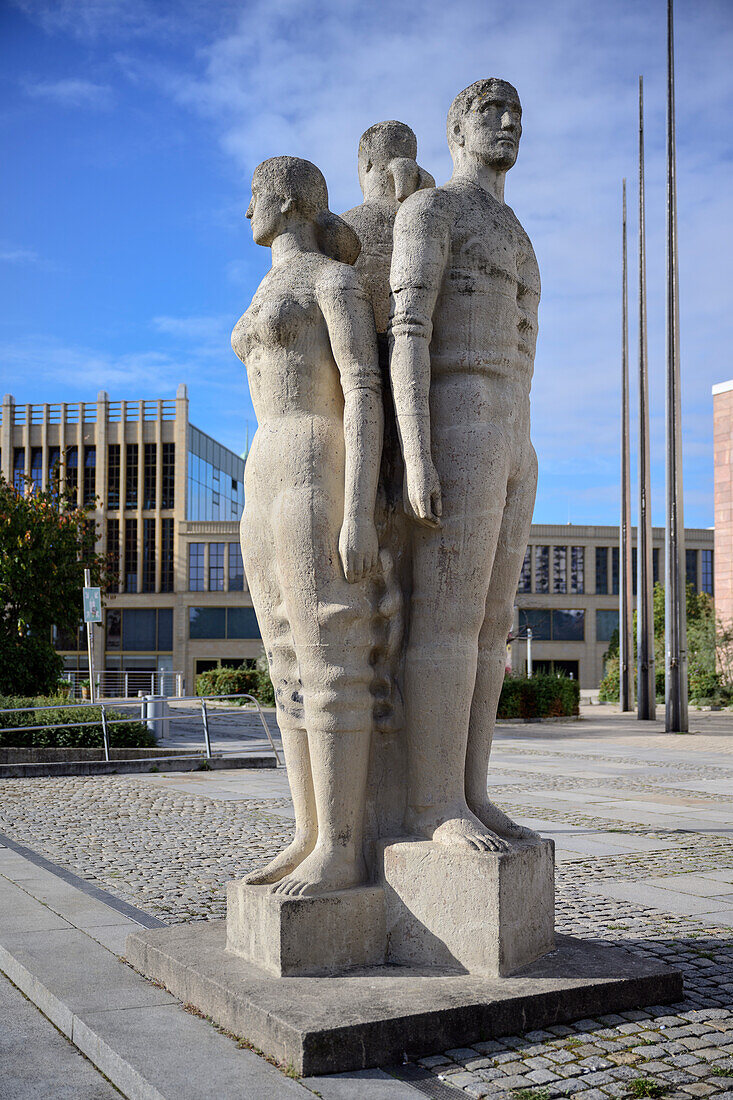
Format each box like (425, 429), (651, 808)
(466, 444), (537, 839)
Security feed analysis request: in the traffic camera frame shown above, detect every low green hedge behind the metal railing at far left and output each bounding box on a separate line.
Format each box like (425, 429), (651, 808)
(0, 695), (155, 748)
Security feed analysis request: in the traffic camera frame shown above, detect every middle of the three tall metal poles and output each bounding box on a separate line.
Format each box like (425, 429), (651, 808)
(636, 77), (657, 721)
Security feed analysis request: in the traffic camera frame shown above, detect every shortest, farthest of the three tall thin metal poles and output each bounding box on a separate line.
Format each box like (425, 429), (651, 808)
(619, 179), (634, 711)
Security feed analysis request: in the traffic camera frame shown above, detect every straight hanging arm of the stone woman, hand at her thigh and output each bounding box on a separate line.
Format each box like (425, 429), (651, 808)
(317, 266), (384, 582)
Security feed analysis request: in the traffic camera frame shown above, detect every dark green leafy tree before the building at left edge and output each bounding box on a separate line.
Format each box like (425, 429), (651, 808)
(0, 474), (108, 695)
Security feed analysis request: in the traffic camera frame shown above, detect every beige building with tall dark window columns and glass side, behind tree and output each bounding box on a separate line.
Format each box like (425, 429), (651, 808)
(0, 385), (262, 692)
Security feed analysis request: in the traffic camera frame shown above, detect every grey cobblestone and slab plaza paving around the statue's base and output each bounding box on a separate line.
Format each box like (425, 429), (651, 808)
(0, 707), (733, 1100)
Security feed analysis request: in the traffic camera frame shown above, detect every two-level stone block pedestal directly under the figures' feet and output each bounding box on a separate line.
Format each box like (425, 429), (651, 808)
(227, 838), (555, 978)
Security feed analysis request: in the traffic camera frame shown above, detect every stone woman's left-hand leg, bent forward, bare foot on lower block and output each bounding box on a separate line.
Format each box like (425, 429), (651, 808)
(241, 505), (318, 886)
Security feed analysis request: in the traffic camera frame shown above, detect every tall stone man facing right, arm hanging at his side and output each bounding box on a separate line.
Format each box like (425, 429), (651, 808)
(390, 78), (539, 851)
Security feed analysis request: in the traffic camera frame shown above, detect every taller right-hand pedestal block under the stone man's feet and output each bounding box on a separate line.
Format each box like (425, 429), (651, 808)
(378, 840), (555, 977)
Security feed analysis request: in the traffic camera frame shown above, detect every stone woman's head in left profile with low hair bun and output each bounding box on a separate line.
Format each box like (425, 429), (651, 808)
(247, 156), (361, 264)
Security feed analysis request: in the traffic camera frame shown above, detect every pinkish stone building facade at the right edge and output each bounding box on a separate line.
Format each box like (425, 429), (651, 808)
(712, 380), (733, 626)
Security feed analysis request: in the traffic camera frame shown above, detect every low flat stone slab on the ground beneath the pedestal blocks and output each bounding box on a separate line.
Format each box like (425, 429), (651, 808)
(127, 921), (682, 1076)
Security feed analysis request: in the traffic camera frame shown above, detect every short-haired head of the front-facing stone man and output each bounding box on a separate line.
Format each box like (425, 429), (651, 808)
(448, 77), (522, 172)
